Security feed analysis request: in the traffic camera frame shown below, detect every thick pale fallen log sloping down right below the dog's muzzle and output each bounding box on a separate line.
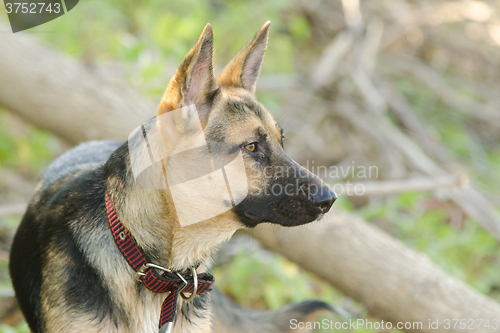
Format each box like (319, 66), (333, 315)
(246, 210), (500, 333)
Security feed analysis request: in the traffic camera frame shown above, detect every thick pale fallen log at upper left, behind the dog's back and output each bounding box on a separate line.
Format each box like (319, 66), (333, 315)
(0, 22), (155, 143)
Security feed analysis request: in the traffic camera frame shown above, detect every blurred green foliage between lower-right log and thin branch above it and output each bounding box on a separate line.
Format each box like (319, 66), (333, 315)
(358, 185), (500, 300)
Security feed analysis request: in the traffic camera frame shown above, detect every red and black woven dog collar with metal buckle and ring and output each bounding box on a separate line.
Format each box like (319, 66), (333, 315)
(106, 192), (215, 328)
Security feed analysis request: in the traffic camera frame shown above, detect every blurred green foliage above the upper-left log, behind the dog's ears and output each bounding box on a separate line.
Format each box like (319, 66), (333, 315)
(32, 0), (298, 97)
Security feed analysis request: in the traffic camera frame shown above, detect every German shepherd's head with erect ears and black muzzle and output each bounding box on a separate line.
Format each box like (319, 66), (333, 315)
(158, 22), (336, 227)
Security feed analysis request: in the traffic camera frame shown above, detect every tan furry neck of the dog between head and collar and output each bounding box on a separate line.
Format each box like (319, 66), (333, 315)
(104, 143), (243, 270)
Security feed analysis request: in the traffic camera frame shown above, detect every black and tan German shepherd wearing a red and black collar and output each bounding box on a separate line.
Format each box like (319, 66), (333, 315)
(10, 22), (336, 333)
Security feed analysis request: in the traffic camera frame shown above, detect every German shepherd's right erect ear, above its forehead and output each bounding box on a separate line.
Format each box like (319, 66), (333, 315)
(217, 21), (271, 93)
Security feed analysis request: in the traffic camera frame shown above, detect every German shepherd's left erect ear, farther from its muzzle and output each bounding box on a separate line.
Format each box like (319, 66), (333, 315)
(158, 24), (217, 124)
